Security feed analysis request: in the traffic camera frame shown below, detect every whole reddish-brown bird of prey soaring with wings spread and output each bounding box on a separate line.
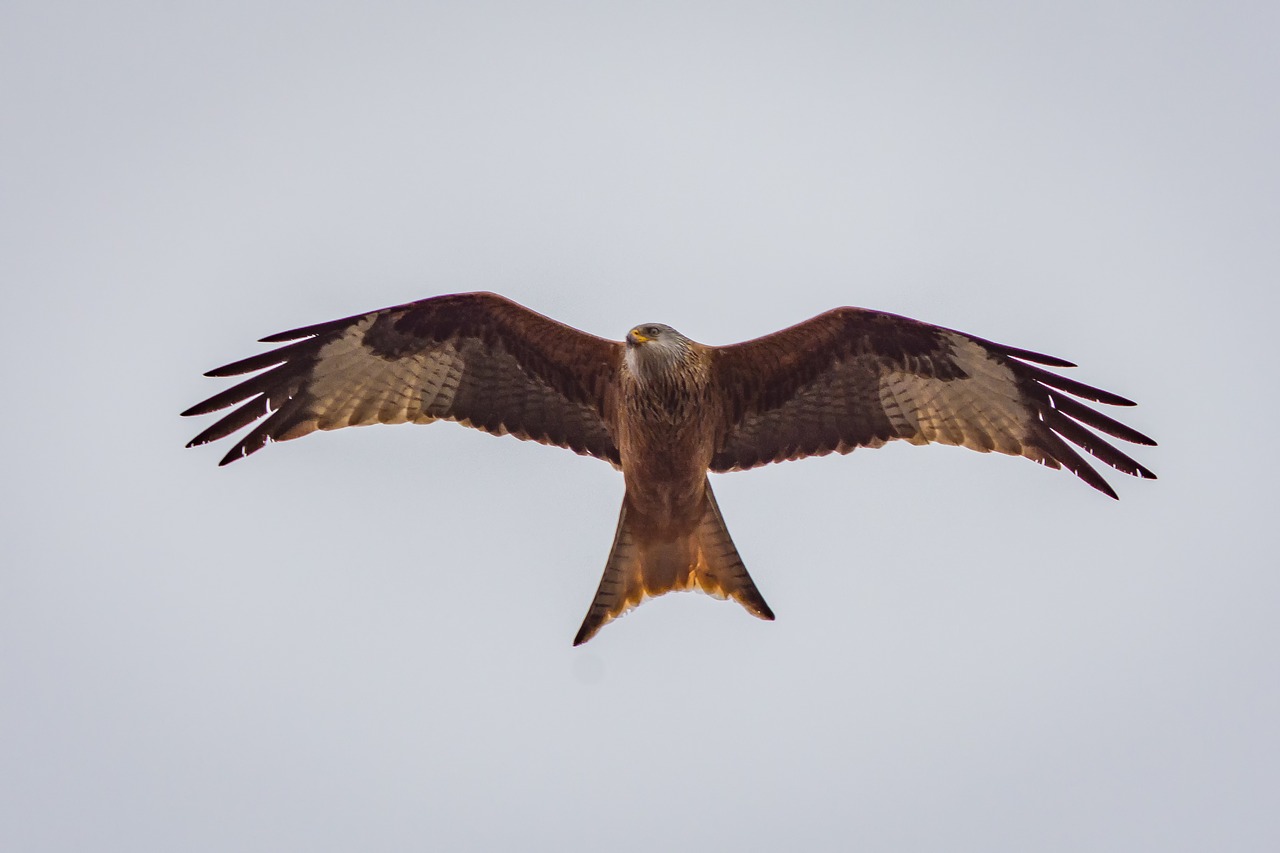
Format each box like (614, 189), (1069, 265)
(183, 293), (1155, 646)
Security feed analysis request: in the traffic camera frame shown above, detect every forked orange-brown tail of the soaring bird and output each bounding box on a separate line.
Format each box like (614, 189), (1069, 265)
(573, 483), (773, 646)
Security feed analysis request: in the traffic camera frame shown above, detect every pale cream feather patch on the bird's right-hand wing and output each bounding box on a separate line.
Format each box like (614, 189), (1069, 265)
(879, 334), (1028, 455)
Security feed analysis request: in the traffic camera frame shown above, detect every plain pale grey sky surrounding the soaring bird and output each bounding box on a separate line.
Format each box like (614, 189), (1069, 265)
(0, 0), (1280, 852)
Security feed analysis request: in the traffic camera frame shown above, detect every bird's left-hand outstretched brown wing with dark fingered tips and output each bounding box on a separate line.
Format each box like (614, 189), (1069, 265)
(182, 293), (622, 465)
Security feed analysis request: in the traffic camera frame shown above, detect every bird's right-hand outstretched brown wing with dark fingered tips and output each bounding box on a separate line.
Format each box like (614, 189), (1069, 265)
(712, 307), (1156, 497)
